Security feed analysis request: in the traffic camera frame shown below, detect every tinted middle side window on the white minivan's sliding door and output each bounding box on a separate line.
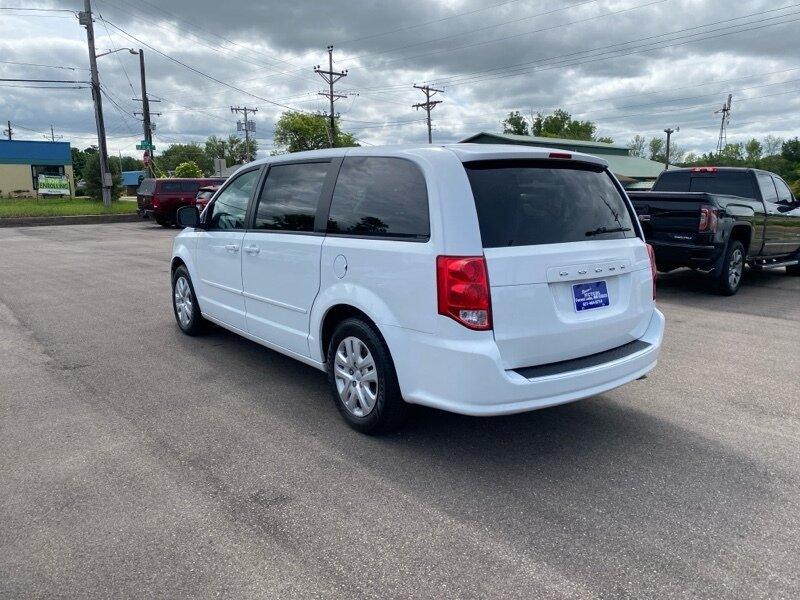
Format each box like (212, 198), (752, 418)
(255, 162), (330, 231)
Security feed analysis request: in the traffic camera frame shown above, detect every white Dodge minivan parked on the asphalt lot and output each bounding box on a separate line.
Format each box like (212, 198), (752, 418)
(172, 144), (664, 433)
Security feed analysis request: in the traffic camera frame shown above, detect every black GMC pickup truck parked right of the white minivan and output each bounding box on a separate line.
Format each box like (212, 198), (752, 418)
(628, 167), (800, 296)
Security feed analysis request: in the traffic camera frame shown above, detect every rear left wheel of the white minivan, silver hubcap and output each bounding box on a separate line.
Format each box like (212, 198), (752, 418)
(327, 318), (408, 434)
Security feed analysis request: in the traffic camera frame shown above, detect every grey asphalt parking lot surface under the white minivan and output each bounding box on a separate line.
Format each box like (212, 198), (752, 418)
(0, 223), (800, 599)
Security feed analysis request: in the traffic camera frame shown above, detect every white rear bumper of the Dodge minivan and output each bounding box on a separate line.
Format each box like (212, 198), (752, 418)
(384, 310), (664, 416)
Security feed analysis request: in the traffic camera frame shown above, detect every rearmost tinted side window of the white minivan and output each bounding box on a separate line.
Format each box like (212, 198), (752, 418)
(328, 156), (430, 239)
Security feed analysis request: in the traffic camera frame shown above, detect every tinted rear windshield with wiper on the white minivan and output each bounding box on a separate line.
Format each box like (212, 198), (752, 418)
(464, 160), (636, 248)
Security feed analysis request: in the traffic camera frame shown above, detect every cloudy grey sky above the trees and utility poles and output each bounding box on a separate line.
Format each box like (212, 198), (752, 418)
(0, 0), (800, 155)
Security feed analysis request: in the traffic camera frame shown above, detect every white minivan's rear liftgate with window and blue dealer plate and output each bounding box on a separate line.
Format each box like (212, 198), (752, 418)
(464, 159), (653, 369)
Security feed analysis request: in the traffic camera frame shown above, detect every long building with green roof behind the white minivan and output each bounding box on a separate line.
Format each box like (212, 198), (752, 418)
(461, 131), (672, 189)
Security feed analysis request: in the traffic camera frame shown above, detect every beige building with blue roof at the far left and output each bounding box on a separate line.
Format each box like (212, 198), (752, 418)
(0, 140), (75, 198)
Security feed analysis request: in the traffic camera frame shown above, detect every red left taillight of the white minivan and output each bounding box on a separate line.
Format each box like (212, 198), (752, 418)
(436, 256), (492, 331)
